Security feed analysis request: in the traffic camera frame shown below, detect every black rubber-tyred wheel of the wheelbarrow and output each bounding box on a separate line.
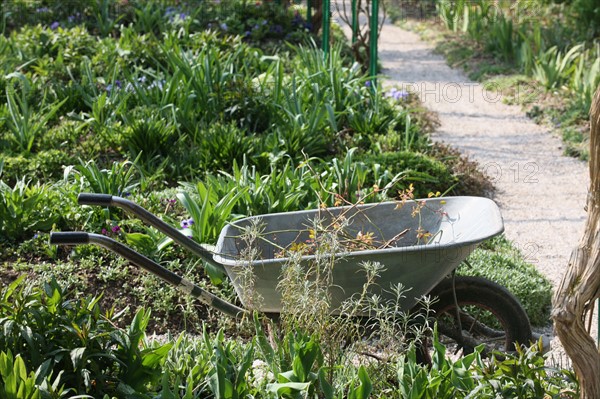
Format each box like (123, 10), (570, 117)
(419, 276), (532, 363)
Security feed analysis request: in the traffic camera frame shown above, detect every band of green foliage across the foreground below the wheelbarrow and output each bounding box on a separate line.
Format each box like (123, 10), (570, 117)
(0, 278), (577, 399)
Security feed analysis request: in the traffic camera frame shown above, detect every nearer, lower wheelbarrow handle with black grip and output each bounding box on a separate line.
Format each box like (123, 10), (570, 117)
(50, 231), (248, 318)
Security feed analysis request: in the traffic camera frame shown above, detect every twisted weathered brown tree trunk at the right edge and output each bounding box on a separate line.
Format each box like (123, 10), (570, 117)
(552, 87), (600, 399)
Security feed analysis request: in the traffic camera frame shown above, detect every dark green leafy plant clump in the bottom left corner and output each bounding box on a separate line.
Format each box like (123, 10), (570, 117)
(0, 275), (172, 399)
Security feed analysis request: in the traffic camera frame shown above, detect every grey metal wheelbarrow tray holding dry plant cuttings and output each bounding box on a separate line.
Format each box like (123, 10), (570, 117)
(214, 197), (503, 313)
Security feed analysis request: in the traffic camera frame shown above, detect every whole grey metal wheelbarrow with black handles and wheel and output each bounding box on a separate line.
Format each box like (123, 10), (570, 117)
(50, 193), (532, 351)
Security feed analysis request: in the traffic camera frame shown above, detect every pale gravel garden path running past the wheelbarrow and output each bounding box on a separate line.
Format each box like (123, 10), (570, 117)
(364, 19), (596, 364)
